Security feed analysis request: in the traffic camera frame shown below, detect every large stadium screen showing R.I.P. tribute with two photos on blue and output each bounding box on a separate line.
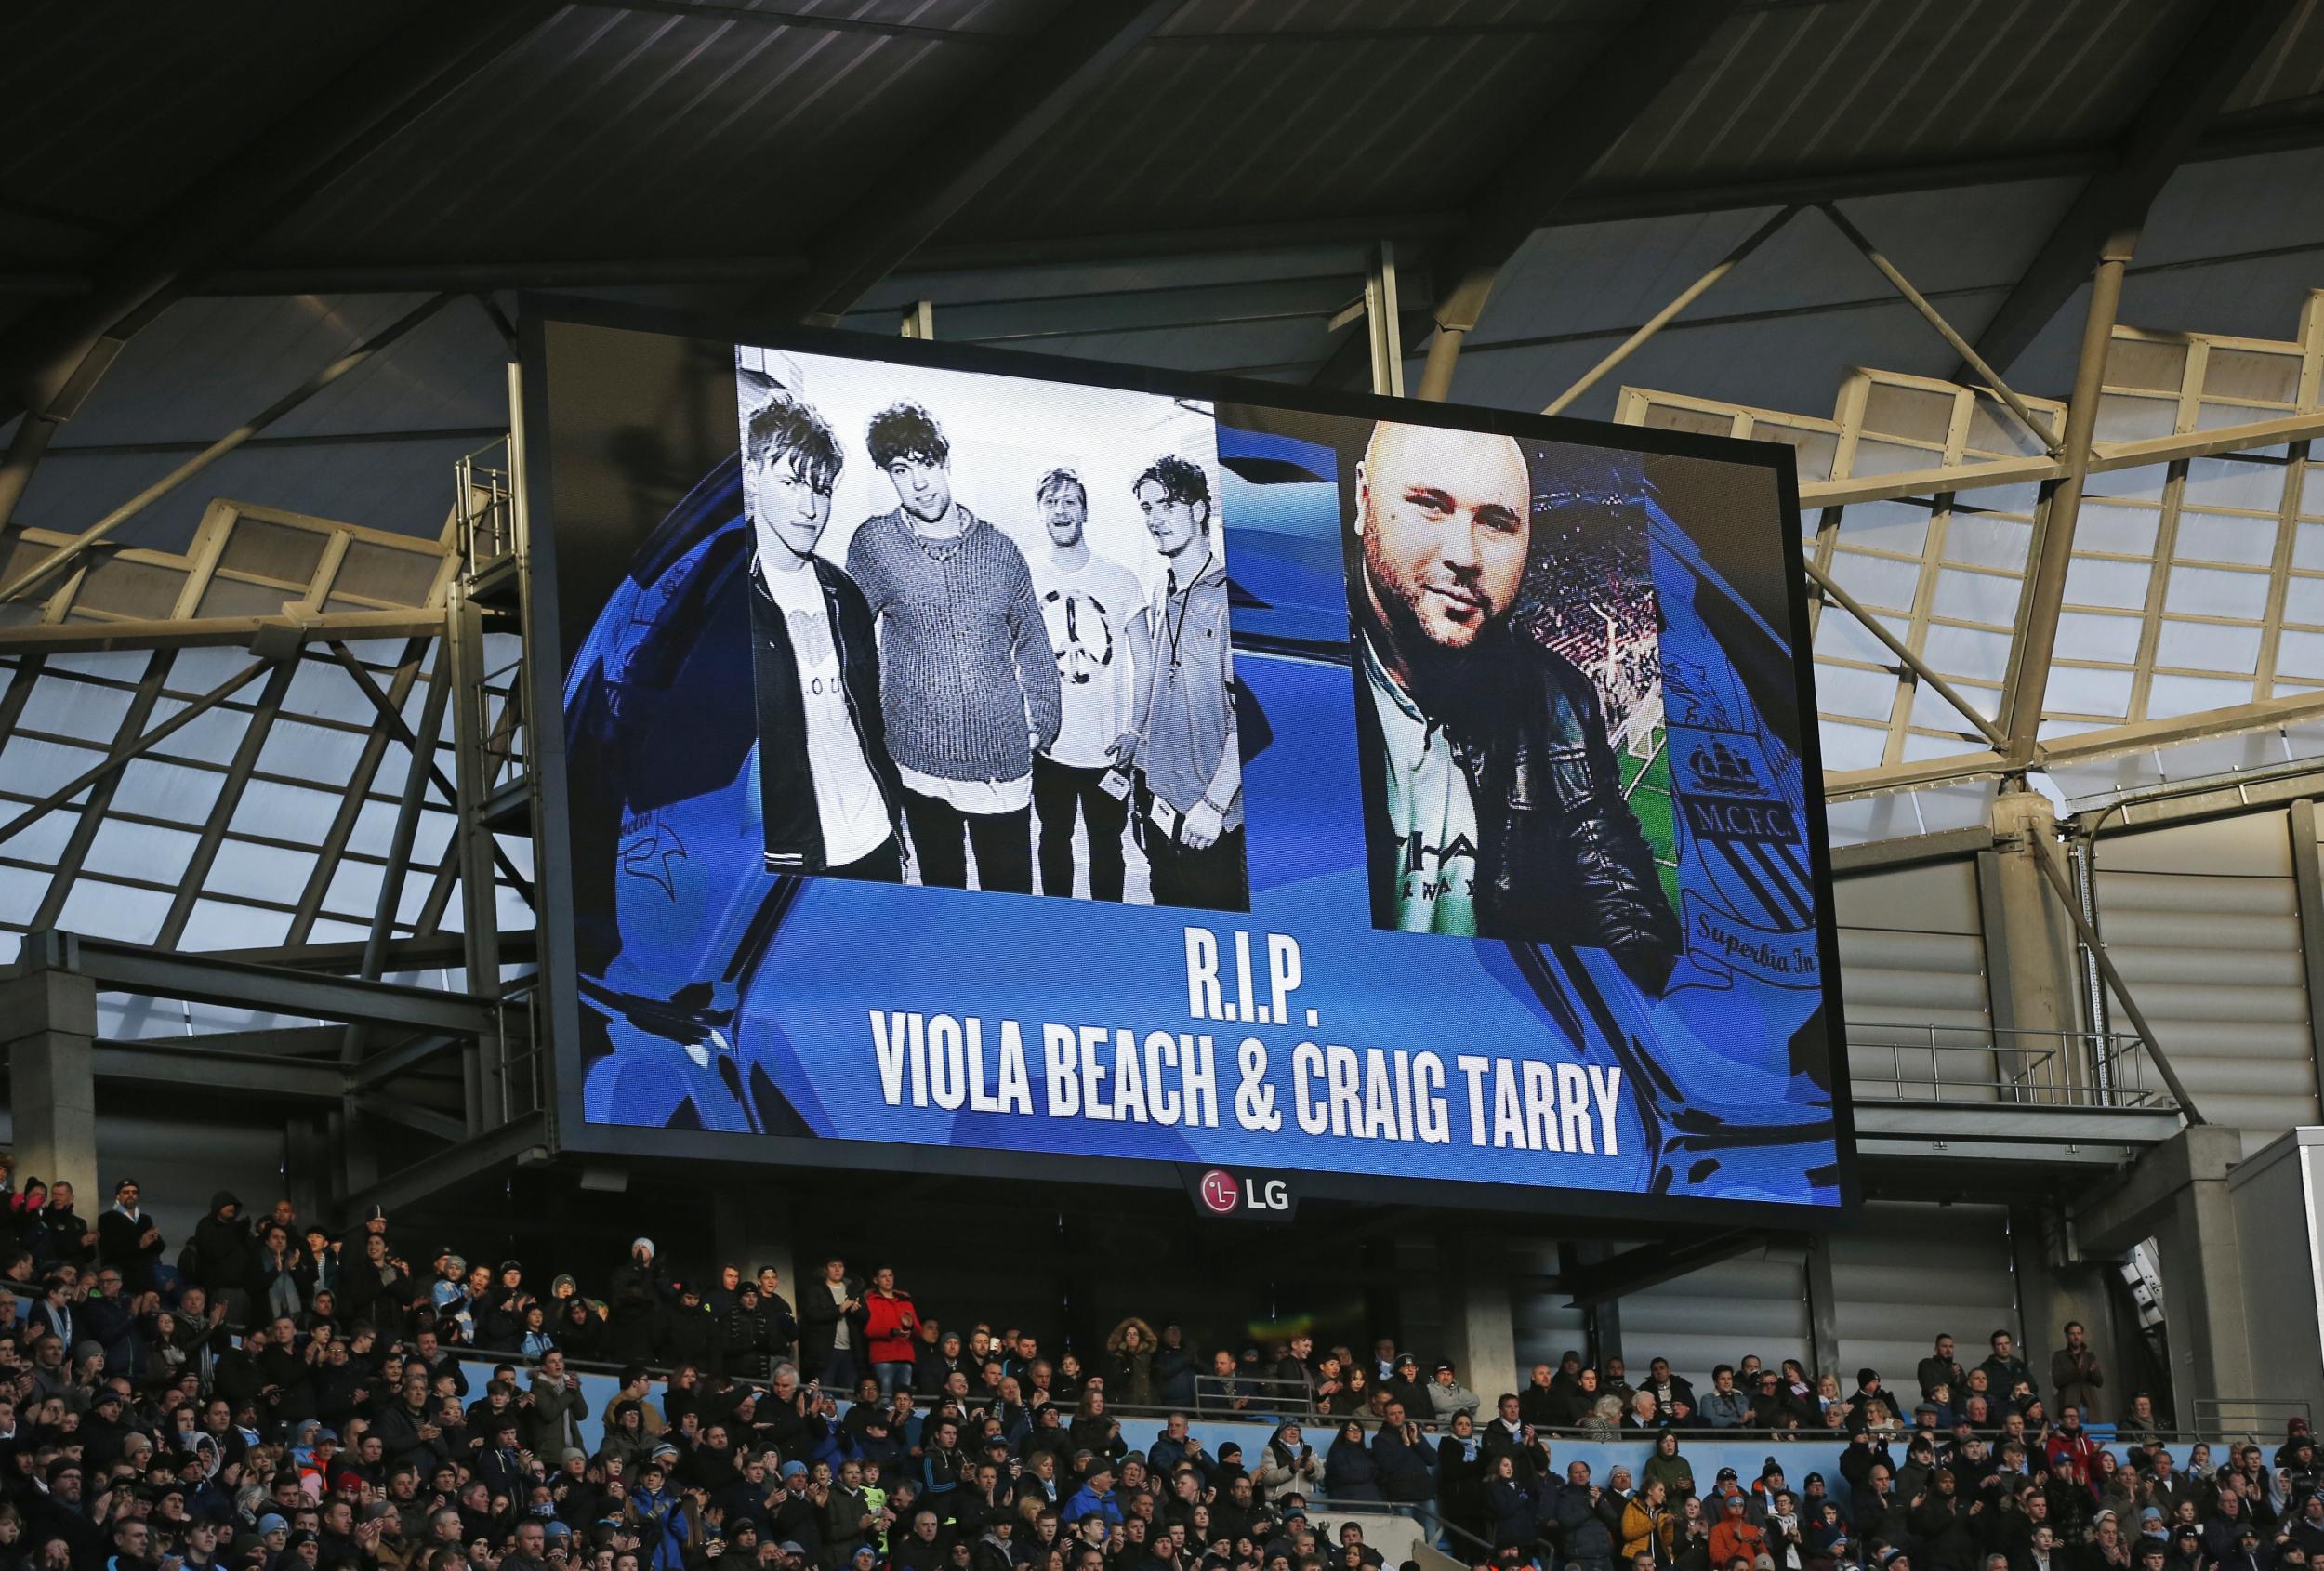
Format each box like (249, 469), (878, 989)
(528, 304), (1853, 1218)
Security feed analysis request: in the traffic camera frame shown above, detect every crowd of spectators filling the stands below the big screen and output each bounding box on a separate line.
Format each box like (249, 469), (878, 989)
(0, 1179), (2324, 1571)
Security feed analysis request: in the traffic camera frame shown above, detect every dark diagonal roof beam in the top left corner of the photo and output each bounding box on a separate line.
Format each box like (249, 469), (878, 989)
(0, 0), (558, 421)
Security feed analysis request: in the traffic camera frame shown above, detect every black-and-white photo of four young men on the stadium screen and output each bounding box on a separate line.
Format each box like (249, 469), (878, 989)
(737, 349), (1248, 911)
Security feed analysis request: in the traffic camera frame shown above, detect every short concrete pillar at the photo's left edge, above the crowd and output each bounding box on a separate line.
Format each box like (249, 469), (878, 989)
(0, 960), (105, 1218)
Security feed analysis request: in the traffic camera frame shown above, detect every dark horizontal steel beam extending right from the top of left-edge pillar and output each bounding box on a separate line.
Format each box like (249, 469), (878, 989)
(23, 930), (500, 1041)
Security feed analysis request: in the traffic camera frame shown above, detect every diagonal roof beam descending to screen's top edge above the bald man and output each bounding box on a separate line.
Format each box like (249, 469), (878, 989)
(1420, 0), (1732, 403)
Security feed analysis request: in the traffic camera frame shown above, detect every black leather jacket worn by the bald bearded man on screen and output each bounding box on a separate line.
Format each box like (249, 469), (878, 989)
(1355, 627), (1681, 993)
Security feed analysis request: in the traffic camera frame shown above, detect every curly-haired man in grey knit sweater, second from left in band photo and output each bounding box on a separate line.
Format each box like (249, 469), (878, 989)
(849, 403), (1060, 895)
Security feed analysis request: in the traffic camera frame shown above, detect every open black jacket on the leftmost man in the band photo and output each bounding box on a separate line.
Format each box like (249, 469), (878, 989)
(758, 553), (905, 874)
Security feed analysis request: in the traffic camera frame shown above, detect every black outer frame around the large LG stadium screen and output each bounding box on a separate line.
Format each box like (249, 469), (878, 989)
(519, 293), (1862, 1230)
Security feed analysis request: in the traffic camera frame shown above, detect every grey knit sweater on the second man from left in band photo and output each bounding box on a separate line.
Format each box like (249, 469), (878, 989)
(849, 507), (1060, 781)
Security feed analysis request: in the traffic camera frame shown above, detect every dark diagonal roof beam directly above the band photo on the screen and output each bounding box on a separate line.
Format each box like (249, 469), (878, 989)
(753, 0), (1181, 325)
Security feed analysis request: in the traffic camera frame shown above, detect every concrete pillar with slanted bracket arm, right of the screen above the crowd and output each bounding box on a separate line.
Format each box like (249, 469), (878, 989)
(2076, 1125), (2266, 1427)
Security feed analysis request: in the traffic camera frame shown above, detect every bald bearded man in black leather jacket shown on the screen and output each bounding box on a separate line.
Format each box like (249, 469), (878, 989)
(1351, 423), (1678, 993)
